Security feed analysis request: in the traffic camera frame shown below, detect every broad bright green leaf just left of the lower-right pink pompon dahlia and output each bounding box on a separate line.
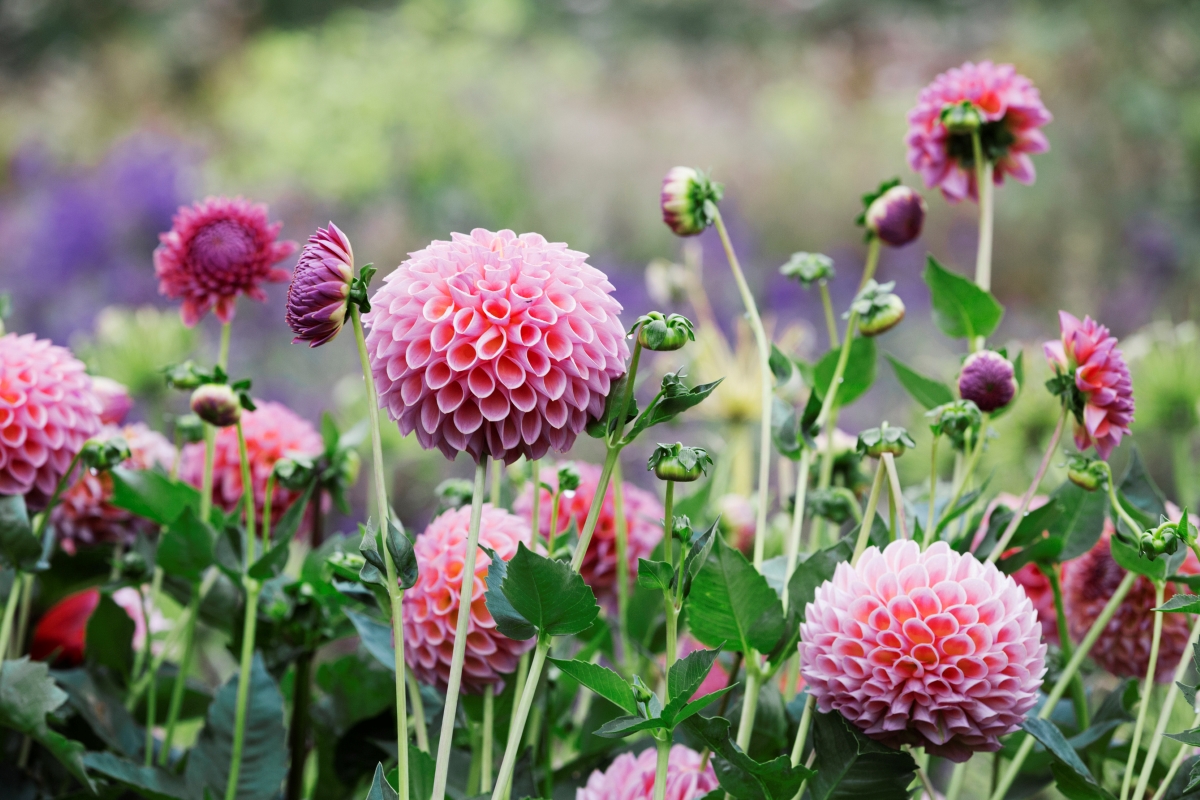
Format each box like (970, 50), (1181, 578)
(688, 537), (784, 652)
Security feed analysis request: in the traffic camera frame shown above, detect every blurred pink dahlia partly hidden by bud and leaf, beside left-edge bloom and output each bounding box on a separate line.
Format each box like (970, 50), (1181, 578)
(52, 422), (175, 555)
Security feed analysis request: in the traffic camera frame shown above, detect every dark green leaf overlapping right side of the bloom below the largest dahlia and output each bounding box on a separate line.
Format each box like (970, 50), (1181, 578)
(500, 542), (600, 636)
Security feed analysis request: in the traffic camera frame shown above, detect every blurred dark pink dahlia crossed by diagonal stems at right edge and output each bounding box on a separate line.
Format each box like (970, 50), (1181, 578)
(1062, 521), (1200, 681)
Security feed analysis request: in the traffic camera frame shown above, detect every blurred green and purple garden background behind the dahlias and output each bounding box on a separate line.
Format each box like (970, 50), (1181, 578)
(0, 0), (1200, 532)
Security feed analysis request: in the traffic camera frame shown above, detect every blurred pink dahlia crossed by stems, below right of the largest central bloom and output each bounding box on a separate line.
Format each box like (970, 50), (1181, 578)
(512, 462), (665, 600)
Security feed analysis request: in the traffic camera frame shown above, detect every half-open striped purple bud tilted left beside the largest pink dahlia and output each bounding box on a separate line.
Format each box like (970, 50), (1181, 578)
(287, 222), (354, 347)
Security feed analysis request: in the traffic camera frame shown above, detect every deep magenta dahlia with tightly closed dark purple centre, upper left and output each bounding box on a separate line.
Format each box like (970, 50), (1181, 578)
(154, 197), (296, 327)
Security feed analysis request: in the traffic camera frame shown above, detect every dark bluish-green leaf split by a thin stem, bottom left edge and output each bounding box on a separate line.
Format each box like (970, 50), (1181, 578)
(184, 652), (288, 800)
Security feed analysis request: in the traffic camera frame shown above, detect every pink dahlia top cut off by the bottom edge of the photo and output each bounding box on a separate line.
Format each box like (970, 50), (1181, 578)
(575, 745), (718, 800)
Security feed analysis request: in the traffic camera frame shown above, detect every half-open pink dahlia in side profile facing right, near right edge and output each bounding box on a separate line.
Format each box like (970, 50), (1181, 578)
(1044, 311), (1134, 458)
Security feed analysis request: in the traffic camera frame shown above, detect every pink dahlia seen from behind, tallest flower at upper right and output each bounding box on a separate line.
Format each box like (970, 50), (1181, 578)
(905, 61), (1052, 203)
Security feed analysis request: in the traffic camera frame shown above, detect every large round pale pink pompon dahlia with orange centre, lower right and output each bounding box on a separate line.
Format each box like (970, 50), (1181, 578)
(800, 541), (1046, 762)
